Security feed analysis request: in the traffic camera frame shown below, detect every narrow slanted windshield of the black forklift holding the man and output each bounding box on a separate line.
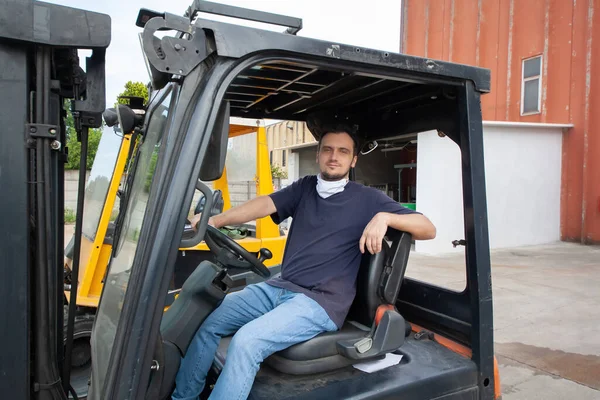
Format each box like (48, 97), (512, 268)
(92, 89), (171, 391)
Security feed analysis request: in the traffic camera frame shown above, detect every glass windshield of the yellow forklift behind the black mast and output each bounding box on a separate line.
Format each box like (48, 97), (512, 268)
(82, 127), (123, 241)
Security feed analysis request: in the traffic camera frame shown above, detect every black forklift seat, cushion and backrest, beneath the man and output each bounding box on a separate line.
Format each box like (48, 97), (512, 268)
(216, 230), (412, 375)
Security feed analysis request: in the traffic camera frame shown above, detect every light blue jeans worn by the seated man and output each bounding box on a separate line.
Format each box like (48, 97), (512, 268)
(172, 282), (337, 400)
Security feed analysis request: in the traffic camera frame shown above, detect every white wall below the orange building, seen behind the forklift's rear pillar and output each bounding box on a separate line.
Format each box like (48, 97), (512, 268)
(416, 123), (563, 253)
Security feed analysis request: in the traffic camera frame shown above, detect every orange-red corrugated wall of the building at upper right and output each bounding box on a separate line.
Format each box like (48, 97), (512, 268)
(402, 0), (600, 243)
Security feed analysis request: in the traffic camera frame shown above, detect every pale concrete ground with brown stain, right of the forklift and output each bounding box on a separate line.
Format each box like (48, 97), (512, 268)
(407, 243), (600, 400)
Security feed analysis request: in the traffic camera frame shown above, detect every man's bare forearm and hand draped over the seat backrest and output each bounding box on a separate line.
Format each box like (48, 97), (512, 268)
(359, 212), (436, 254)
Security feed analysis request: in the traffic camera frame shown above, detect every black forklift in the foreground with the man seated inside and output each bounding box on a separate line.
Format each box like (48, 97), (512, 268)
(0, 0), (500, 400)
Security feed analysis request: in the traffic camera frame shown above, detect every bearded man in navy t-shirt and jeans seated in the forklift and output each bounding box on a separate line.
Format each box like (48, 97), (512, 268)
(173, 126), (435, 400)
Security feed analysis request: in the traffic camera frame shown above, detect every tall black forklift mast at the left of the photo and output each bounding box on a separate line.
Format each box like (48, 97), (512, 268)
(0, 0), (111, 400)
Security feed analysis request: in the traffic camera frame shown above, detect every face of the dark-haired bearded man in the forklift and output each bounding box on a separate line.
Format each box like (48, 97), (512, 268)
(317, 132), (357, 181)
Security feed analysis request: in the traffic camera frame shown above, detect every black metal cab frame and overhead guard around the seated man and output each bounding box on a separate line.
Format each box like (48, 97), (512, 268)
(94, 7), (494, 399)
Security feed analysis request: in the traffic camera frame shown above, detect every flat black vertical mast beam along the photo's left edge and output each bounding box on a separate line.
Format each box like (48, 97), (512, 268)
(0, 37), (32, 400)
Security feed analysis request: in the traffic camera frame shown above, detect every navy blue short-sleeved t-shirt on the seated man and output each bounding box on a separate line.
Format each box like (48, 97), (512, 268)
(267, 175), (415, 328)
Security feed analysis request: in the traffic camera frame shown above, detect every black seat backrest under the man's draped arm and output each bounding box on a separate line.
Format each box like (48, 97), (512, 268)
(347, 229), (412, 326)
